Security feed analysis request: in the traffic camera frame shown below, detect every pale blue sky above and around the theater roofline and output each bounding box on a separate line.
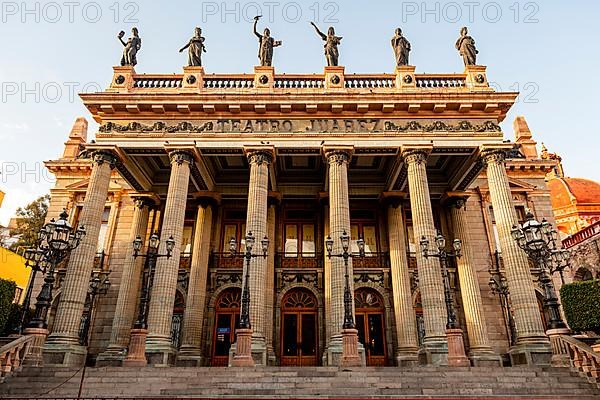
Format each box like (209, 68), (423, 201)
(0, 0), (600, 224)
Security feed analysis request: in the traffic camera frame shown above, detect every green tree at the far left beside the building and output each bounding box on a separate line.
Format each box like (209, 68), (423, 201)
(11, 195), (50, 251)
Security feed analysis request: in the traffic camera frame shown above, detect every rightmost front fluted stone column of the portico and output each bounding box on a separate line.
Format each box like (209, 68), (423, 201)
(482, 149), (551, 365)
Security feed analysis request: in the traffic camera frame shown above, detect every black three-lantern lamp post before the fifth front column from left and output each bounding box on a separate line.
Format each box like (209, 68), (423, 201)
(420, 232), (462, 329)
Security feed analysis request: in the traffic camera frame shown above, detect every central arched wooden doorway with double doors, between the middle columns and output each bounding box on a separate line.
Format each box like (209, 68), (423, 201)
(281, 289), (318, 366)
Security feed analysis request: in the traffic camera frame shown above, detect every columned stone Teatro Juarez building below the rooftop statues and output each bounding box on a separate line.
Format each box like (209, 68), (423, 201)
(39, 66), (556, 366)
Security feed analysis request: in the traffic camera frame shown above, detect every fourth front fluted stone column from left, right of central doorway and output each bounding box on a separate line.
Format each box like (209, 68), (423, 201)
(323, 146), (364, 365)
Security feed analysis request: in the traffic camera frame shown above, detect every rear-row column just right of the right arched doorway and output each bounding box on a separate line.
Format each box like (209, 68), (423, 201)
(388, 199), (419, 366)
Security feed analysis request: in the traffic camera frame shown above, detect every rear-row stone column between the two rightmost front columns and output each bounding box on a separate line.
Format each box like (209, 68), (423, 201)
(449, 197), (502, 366)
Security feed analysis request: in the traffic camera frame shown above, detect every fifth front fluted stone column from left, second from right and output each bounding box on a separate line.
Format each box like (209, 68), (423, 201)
(403, 148), (448, 365)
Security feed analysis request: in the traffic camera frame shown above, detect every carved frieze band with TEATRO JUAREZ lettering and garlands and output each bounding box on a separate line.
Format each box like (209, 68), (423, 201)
(100, 119), (501, 133)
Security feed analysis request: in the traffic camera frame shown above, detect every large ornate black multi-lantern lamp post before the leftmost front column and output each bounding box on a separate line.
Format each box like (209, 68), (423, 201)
(28, 210), (85, 329)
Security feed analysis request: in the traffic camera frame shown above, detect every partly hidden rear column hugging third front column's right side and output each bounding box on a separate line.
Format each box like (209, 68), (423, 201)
(265, 197), (278, 365)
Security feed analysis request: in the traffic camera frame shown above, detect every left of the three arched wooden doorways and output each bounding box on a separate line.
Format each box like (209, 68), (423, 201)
(211, 288), (242, 367)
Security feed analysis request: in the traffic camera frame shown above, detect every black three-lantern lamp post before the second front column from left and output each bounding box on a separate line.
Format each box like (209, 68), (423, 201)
(133, 232), (175, 329)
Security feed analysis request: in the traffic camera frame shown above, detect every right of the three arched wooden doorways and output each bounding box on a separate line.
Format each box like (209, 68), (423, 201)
(354, 288), (387, 366)
